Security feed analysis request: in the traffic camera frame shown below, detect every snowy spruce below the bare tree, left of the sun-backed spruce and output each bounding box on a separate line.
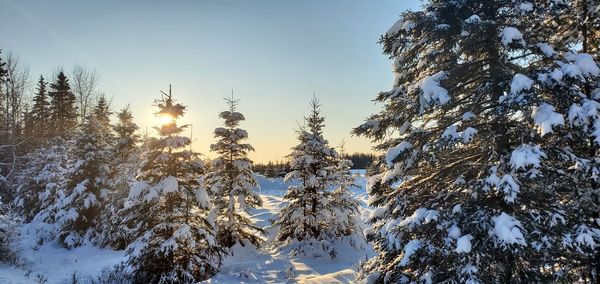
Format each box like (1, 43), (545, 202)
(56, 97), (114, 248)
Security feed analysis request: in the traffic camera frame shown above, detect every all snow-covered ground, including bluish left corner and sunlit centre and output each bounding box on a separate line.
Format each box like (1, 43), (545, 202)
(0, 170), (374, 283)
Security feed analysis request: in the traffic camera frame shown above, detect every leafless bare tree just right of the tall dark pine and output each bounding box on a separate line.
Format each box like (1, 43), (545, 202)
(71, 64), (100, 122)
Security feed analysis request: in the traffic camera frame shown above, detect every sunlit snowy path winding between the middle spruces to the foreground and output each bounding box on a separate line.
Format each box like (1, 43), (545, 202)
(209, 174), (373, 283)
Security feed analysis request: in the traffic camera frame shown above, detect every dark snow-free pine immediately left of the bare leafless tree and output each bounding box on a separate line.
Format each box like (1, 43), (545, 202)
(48, 71), (77, 138)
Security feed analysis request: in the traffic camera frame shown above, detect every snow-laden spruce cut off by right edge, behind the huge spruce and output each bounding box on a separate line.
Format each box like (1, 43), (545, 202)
(527, 0), (600, 282)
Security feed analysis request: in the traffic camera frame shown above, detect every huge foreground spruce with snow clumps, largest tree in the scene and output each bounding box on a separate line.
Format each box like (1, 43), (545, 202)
(354, 0), (598, 283)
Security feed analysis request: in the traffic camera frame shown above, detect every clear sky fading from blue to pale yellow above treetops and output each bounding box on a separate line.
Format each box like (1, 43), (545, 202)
(0, 0), (420, 162)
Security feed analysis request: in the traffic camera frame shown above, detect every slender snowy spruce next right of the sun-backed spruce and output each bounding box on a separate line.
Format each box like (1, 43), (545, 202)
(205, 97), (264, 248)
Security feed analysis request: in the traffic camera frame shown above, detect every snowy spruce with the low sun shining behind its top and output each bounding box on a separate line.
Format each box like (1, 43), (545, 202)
(120, 88), (223, 283)
